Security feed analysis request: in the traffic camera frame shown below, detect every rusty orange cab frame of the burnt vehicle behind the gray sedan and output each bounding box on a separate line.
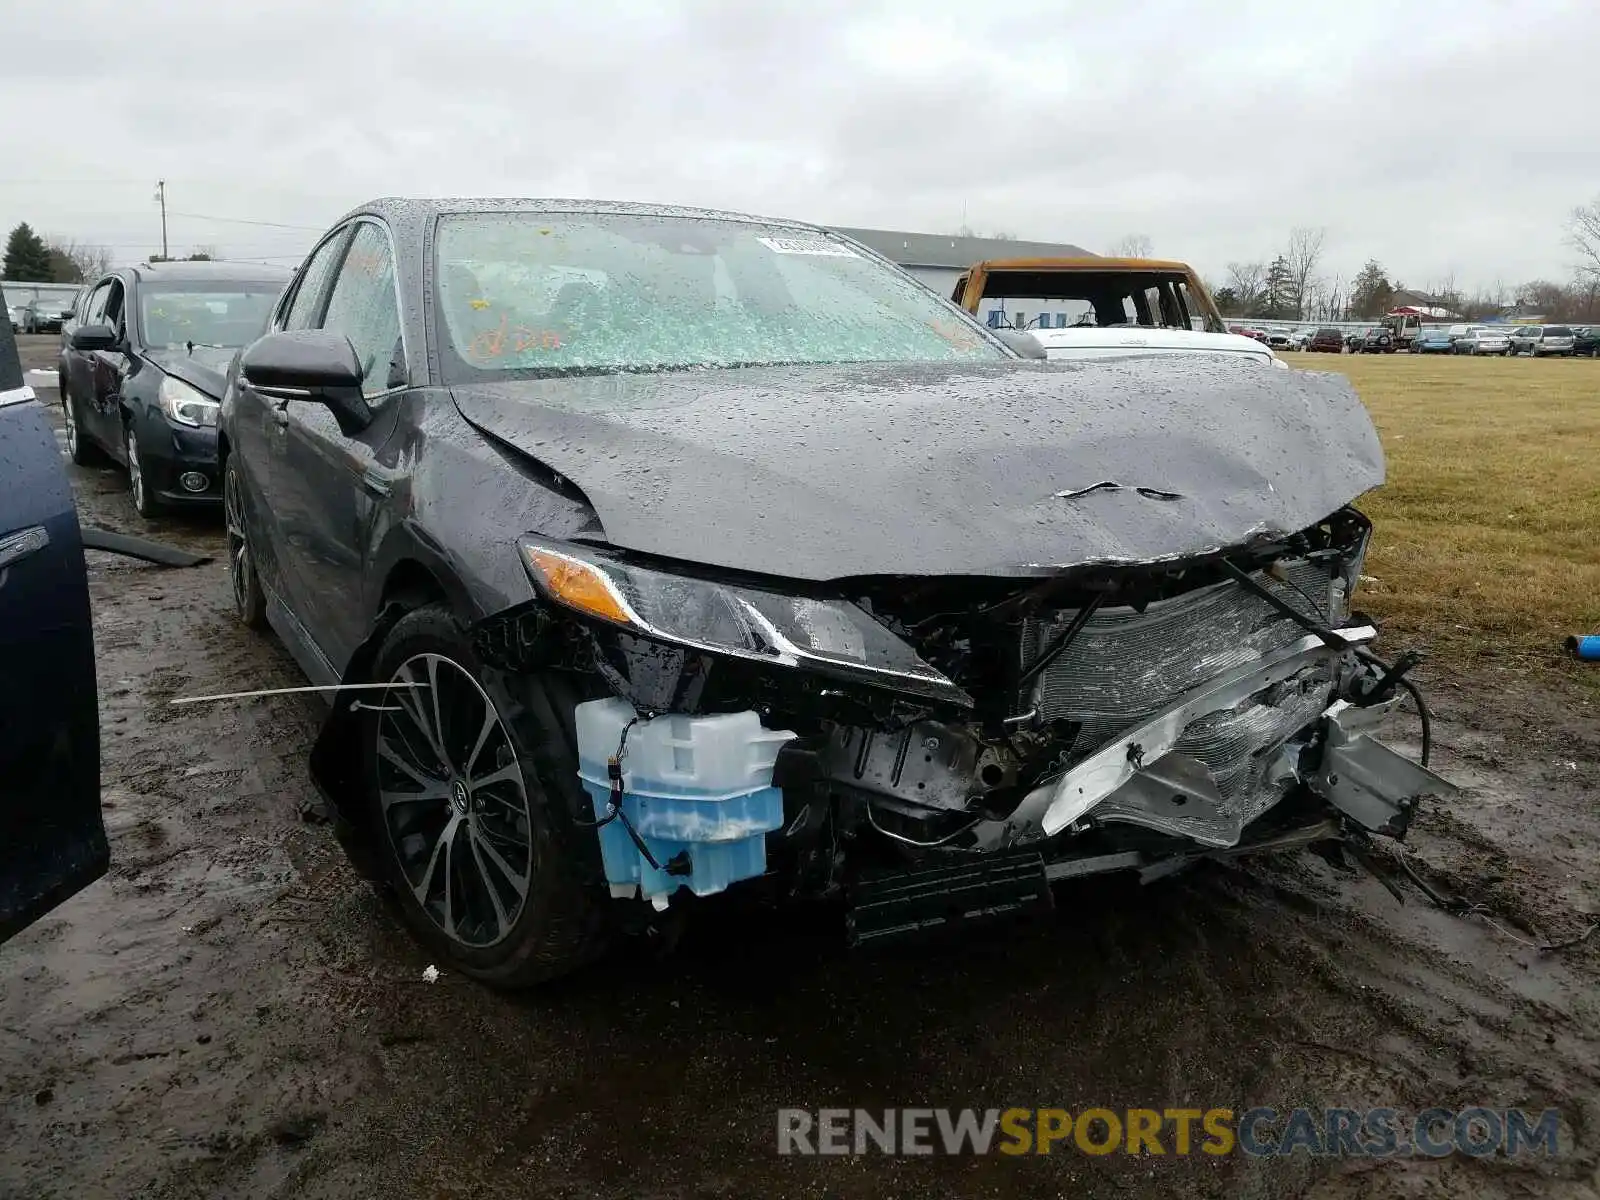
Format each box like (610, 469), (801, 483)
(950, 256), (1227, 333)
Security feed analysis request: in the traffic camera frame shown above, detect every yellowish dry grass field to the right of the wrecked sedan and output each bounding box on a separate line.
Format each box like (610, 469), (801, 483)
(1285, 354), (1600, 683)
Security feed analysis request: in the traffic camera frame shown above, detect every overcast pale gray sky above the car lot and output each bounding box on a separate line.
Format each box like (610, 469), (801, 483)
(0, 0), (1600, 296)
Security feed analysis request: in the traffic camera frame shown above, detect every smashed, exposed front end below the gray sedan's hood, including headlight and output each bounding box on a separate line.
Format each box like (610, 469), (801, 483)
(478, 509), (1453, 939)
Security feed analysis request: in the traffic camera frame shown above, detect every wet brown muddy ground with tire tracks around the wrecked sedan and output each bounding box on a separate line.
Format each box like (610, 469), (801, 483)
(9, 347), (1600, 1200)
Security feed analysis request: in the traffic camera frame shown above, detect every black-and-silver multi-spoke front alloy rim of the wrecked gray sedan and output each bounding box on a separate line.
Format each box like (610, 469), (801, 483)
(376, 654), (533, 949)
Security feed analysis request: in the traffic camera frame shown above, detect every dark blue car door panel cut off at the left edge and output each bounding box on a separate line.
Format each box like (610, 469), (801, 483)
(0, 322), (107, 941)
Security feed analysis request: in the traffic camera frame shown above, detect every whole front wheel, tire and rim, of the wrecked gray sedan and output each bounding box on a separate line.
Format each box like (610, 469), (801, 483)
(360, 605), (605, 989)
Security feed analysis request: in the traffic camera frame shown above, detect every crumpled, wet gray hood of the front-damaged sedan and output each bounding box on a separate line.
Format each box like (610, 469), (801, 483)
(453, 355), (1384, 581)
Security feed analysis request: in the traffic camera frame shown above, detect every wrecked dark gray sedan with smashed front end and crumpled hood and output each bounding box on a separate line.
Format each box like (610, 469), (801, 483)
(221, 200), (1450, 986)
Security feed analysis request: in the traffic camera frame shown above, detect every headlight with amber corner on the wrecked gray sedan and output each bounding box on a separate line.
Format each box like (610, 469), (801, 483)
(517, 538), (971, 706)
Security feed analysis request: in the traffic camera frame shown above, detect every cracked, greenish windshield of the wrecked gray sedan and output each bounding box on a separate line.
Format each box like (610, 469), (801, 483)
(435, 213), (1008, 381)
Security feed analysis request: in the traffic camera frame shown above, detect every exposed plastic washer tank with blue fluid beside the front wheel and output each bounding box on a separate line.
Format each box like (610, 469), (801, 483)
(576, 699), (795, 909)
